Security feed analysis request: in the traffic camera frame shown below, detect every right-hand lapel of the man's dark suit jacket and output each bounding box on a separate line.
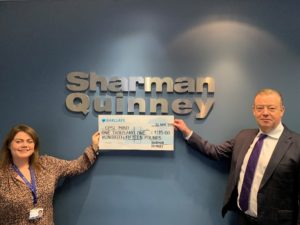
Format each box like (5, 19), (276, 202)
(259, 128), (292, 189)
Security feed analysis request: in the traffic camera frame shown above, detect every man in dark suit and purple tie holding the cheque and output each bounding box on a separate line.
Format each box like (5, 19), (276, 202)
(174, 89), (300, 225)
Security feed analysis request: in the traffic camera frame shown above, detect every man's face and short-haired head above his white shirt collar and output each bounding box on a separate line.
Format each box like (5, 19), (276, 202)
(253, 93), (284, 132)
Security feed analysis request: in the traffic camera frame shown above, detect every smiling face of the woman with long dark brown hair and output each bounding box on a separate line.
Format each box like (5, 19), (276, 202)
(10, 131), (35, 161)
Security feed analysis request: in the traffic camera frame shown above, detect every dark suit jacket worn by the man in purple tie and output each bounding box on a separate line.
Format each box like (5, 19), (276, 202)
(187, 126), (300, 225)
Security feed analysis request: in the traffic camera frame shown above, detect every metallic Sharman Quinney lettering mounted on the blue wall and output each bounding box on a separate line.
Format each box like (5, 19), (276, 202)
(66, 72), (215, 119)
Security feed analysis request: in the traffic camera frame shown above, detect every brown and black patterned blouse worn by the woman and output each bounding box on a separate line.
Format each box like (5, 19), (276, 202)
(0, 147), (96, 225)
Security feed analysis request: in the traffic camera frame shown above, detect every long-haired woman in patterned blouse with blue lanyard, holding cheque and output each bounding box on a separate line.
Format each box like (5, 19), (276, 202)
(0, 124), (100, 225)
